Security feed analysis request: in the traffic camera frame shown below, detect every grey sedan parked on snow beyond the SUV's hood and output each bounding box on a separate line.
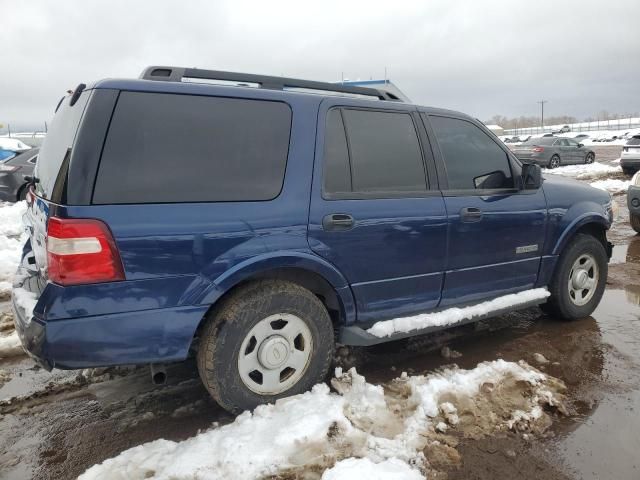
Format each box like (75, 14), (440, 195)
(511, 137), (596, 168)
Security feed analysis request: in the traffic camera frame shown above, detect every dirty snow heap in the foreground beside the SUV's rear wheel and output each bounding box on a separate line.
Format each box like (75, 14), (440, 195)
(79, 360), (565, 480)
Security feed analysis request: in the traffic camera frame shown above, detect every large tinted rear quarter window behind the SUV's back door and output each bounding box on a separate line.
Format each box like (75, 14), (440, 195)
(93, 92), (291, 204)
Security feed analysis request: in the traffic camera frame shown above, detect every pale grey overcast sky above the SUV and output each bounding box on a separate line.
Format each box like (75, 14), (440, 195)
(0, 0), (640, 128)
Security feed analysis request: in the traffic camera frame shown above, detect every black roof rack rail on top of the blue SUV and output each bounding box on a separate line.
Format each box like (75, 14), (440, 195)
(140, 66), (400, 102)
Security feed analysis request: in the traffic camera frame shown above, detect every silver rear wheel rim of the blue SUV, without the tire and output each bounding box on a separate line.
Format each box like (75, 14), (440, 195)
(238, 313), (313, 395)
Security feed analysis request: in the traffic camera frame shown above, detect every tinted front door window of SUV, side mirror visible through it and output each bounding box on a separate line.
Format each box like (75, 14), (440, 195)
(429, 116), (513, 190)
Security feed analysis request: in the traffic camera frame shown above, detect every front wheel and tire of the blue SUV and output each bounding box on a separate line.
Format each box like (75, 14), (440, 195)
(544, 233), (608, 320)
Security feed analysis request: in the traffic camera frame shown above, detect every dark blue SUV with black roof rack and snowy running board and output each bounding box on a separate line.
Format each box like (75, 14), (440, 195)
(13, 67), (612, 411)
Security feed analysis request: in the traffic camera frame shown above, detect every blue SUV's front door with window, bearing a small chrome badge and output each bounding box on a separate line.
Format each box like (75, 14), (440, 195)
(423, 113), (547, 306)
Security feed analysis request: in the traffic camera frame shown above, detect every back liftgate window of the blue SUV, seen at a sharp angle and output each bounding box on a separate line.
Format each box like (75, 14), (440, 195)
(34, 90), (91, 199)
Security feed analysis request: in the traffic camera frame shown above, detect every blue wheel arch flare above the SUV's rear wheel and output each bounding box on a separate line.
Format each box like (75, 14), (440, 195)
(196, 251), (356, 324)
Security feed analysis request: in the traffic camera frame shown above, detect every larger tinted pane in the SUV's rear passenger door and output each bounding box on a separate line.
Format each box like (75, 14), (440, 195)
(343, 109), (427, 192)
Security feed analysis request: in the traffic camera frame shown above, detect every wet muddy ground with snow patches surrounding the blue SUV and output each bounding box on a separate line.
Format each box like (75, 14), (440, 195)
(0, 146), (640, 480)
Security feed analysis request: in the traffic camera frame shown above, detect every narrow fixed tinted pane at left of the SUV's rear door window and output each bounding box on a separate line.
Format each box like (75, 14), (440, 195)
(324, 108), (351, 193)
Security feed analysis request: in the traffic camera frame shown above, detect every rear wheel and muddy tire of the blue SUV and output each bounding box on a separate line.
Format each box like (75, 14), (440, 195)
(198, 280), (334, 413)
